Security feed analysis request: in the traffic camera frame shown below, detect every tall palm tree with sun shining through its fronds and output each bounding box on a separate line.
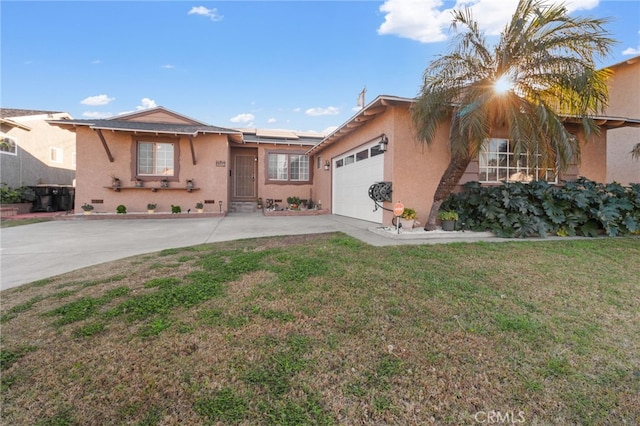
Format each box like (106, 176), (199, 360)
(412, 0), (614, 230)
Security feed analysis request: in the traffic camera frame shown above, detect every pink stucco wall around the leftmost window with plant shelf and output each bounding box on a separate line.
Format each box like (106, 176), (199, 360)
(75, 127), (229, 213)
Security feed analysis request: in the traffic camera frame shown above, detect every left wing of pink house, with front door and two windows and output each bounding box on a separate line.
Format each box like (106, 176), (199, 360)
(51, 107), (321, 213)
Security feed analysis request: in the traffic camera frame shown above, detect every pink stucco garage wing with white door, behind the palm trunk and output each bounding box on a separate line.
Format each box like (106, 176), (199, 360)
(307, 96), (640, 224)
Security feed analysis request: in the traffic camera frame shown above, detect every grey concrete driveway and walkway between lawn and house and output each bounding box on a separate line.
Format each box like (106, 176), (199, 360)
(0, 213), (498, 290)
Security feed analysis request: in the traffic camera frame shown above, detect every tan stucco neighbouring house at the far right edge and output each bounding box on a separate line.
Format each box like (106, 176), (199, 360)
(606, 56), (640, 185)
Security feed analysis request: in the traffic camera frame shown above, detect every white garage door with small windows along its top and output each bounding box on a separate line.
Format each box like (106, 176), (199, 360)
(332, 144), (384, 223)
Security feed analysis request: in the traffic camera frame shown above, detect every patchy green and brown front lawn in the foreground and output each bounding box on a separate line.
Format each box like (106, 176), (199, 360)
(0, 234), (640, 425)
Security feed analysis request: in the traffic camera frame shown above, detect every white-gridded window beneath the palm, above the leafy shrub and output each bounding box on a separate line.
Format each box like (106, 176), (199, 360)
(479, 139), (558, 183)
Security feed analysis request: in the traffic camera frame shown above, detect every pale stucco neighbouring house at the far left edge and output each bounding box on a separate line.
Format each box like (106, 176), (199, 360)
(0, 108), (76, 188)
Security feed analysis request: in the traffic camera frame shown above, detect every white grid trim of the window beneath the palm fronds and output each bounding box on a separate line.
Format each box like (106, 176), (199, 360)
(478, 137), (558, 184)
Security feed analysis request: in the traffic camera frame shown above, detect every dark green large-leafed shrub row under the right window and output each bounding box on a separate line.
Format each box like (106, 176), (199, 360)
(441, 178), (640, 238)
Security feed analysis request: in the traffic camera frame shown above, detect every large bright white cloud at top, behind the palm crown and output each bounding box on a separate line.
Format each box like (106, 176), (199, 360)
(378, 0), (599, 43)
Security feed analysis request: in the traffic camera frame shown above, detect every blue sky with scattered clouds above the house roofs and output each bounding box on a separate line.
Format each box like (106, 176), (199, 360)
(0, 0), (640, 131)
